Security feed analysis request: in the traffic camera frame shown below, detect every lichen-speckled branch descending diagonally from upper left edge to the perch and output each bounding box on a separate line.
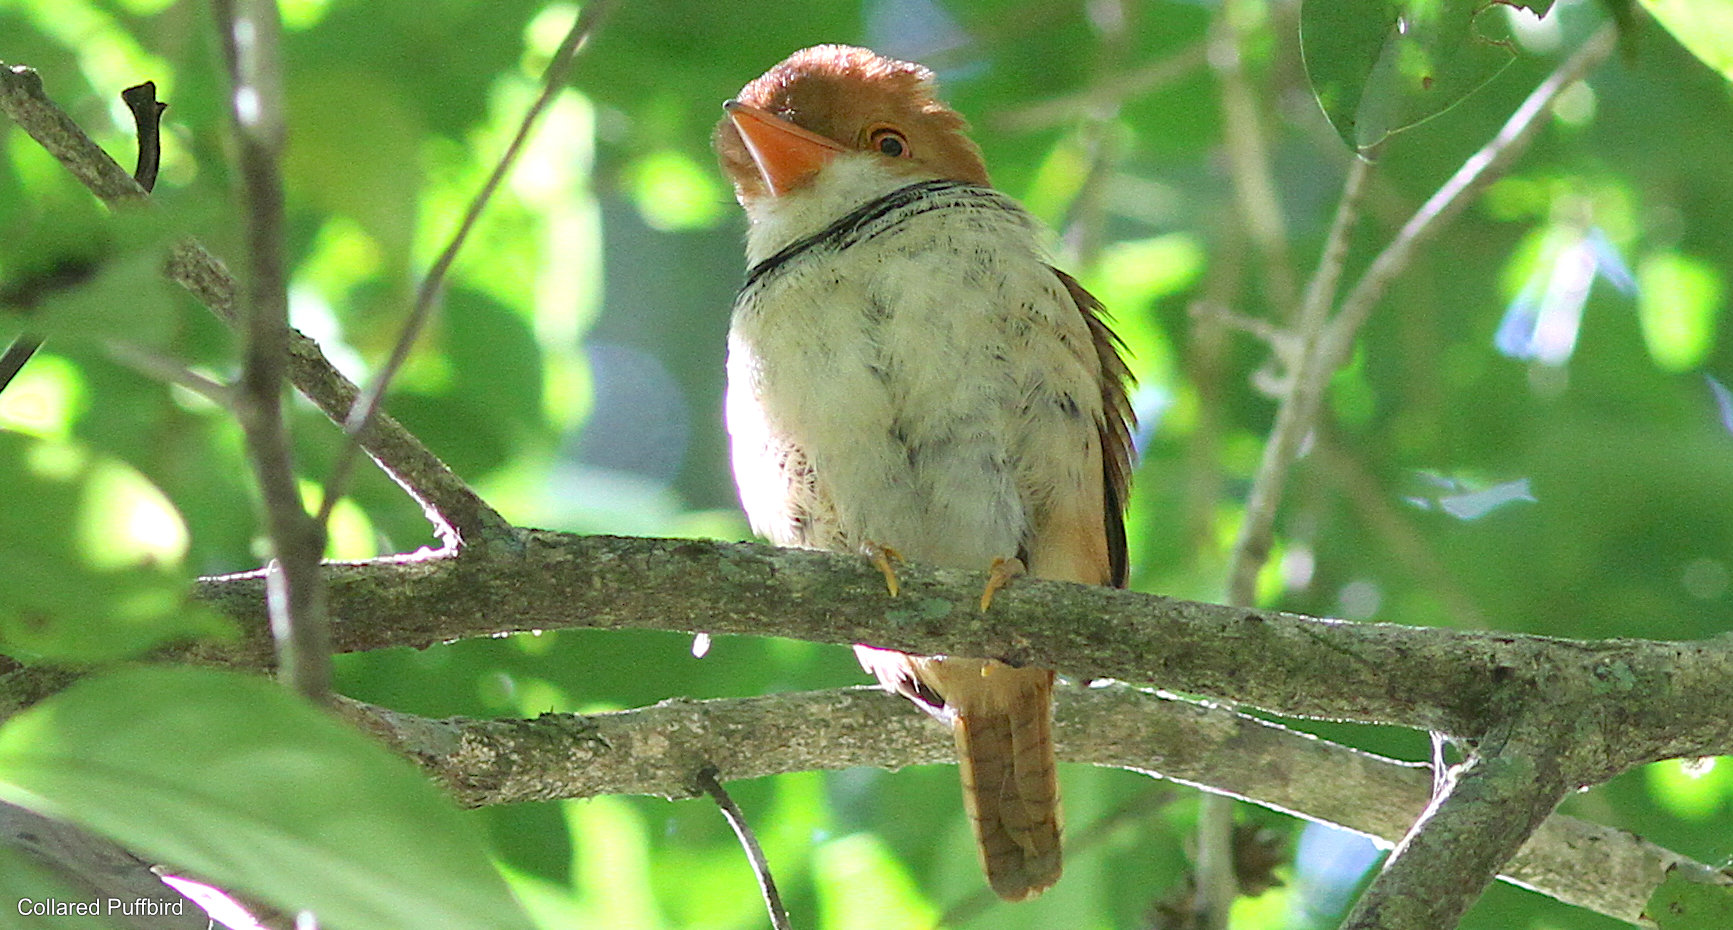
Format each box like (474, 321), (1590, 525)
(0, 64), (515, 547)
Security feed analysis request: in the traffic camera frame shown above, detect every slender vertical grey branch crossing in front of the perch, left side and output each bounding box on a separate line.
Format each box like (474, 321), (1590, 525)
(213, 0), (331, 703)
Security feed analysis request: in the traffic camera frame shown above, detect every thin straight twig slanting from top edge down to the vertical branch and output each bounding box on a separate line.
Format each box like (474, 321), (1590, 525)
(317, 0), (613, 525)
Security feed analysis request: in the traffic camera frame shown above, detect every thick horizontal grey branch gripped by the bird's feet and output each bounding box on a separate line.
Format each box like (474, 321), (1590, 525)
(177, 530), (1733, 765)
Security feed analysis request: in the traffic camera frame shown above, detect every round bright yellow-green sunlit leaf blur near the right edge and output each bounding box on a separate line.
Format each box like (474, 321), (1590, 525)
(1636, 251), (1724, 371)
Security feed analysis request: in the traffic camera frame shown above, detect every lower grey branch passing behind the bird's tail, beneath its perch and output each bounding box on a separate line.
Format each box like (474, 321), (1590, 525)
(341, 686), (1714, 923)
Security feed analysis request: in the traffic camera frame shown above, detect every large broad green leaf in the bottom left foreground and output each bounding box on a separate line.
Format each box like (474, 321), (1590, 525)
(0, 668), (530, 930)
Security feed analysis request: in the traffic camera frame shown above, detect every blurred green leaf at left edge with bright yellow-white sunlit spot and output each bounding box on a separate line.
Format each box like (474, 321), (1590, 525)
(0, 431), (232, 662)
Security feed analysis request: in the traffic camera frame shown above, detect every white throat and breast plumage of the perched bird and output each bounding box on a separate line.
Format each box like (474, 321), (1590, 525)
(726, 156), (1102, 568)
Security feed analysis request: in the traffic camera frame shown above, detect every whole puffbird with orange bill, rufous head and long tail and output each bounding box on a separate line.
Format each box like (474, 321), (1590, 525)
(716, 45), (1132, 901)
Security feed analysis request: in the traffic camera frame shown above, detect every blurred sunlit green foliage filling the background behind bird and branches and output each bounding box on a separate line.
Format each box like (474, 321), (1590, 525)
(0, 0), (1733, 930)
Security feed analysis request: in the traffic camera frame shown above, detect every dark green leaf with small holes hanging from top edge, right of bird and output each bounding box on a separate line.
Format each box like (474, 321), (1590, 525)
(1300, 0), (1518, 152)
